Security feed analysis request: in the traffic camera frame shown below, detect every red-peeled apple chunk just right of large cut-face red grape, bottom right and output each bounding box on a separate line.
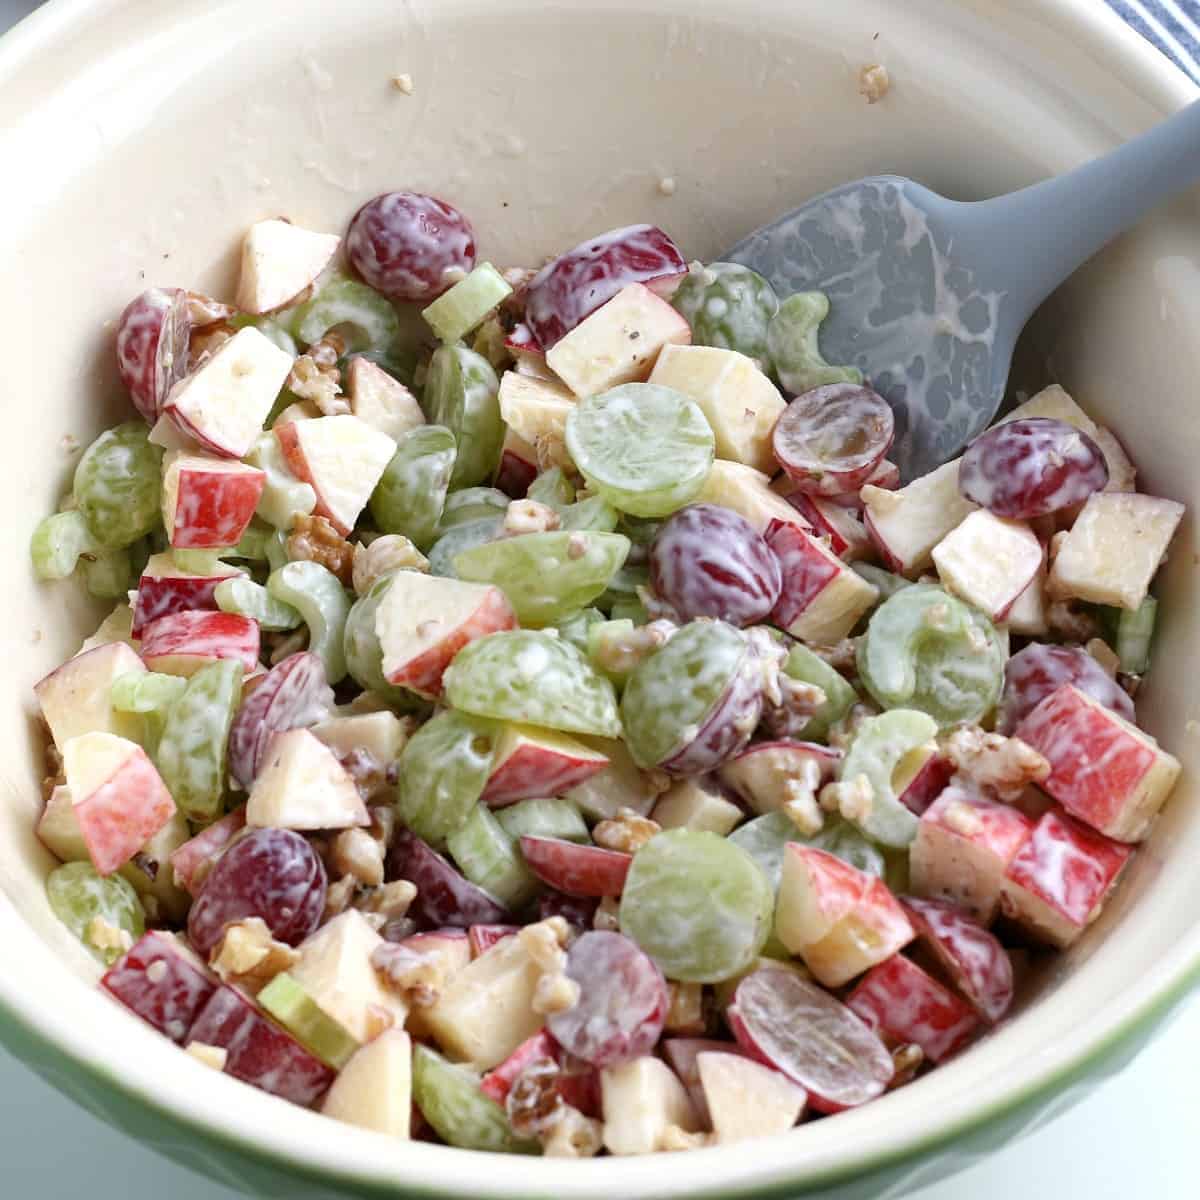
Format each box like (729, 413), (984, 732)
(846, 954), (979, 1063)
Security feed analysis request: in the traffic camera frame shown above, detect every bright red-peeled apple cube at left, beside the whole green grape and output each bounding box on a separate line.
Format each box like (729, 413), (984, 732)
(162, 451), (266, 550)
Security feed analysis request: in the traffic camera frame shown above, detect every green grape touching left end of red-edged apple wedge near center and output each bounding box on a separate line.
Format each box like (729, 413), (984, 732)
(396, 709), (499, 849)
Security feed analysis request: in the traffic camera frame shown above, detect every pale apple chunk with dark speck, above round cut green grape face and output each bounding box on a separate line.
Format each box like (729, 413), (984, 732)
(546, 283), (691, 396)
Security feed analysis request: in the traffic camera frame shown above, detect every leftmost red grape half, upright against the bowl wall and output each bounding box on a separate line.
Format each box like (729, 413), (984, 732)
(116, 288), (192, 425)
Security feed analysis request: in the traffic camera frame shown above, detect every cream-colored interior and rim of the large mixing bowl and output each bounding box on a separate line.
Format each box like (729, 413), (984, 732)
(0, 0), (1200, 1198)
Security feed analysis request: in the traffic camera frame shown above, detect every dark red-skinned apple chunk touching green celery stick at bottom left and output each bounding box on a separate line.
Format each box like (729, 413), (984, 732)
(188, 984), (337, 1108)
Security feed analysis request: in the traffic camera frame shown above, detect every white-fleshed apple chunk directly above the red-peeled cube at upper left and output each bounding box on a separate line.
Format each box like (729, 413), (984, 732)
(163, 325), (293, 458)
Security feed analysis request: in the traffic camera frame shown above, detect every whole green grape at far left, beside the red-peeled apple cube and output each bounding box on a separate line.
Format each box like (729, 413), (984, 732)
(74, 421), (162, 548)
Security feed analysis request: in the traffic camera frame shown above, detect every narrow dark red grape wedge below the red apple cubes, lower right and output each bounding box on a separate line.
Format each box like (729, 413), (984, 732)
(900, 902), (1020, 1025)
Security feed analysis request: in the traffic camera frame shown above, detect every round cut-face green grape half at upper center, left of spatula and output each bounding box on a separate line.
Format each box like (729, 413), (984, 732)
(566, 383), (714, 517)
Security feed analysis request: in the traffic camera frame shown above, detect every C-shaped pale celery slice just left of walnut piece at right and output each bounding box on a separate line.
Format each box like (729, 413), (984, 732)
(841, 708), (937, 848)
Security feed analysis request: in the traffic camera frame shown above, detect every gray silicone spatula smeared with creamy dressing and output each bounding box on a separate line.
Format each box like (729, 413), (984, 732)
(726, 101), (1200, 480)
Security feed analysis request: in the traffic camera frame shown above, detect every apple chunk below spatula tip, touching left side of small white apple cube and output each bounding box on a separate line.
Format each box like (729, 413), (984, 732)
(859, 458), (977, 576)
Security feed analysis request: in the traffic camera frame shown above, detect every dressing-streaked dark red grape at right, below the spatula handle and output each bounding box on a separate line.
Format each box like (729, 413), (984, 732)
(959, 416), (1109, 521)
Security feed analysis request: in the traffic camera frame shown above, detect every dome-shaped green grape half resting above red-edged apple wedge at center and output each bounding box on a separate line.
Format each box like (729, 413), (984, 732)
(444, 629), (620, 738)
